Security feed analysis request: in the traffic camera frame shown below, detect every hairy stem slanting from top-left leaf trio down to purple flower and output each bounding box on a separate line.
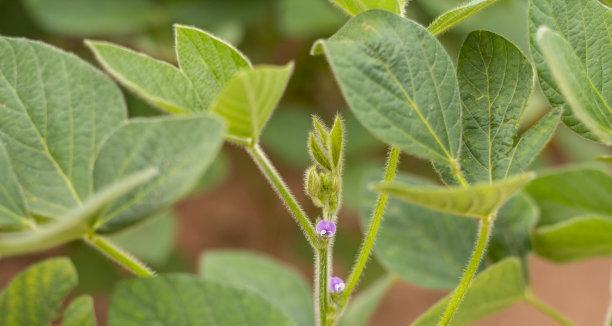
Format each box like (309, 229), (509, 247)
(245, 144), (317, 250)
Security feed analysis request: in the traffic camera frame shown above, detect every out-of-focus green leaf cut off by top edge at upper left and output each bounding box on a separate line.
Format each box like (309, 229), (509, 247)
(23, 0), (165, 37)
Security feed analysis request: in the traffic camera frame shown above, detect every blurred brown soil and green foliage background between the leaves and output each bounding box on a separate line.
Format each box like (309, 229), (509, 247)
(0, 0), (610, 325)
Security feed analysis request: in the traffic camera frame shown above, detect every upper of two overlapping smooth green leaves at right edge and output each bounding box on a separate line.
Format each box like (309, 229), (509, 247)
(525, 167), (612, 226)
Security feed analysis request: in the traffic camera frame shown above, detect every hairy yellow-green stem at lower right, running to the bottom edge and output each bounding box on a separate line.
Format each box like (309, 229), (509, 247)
(438, 212), (497, 326)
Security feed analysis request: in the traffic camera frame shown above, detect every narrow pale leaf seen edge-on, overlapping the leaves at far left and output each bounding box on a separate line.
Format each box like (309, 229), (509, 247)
(0, 169), (157, 256)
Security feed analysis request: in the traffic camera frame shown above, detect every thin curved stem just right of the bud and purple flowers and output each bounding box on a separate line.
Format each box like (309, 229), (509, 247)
(338, 146), (400, 315)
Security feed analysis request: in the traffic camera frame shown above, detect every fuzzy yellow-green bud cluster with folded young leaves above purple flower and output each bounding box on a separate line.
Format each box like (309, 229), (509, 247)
(304, 116), (344, 214)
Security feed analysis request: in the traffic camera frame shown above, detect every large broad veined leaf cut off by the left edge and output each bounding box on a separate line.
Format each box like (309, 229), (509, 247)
(0, 37), (126, 217)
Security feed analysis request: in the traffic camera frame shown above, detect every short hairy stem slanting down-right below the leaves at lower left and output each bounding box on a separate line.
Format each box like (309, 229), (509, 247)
(83, 233), (155, 277)
